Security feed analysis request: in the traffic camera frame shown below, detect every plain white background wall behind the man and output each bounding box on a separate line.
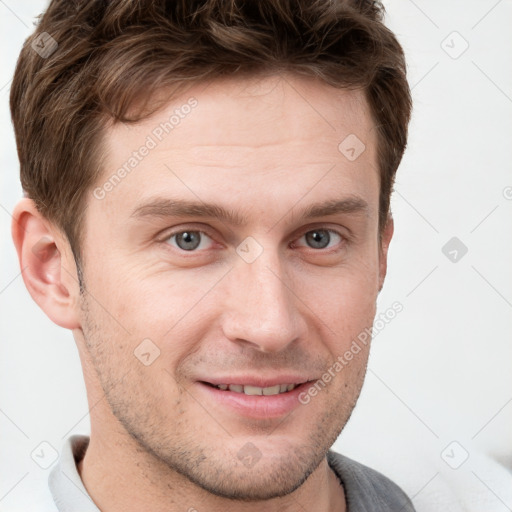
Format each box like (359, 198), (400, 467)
(0, 0), (512, 511)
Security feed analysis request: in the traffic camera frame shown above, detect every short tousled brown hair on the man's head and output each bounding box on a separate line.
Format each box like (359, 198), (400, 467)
(10, 0), (411, 263)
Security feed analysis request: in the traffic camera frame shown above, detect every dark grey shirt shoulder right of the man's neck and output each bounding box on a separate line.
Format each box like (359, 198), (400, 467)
(327, 450), (414, 512)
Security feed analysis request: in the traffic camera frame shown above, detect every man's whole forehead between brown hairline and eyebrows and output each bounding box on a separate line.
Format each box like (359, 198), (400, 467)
(93, 75), (378, 222)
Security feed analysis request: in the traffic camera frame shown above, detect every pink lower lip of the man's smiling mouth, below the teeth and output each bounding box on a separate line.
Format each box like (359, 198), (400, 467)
(198, 382), (312, 419)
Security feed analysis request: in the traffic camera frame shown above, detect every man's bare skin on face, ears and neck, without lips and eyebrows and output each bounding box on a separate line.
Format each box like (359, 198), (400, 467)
(13, 75), (393, 512)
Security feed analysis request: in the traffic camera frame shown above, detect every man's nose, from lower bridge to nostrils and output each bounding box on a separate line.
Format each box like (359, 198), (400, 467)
(222, 250), (305, 352)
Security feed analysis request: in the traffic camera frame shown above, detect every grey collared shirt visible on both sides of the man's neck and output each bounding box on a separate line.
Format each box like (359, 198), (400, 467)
(48, 435), (414, 512)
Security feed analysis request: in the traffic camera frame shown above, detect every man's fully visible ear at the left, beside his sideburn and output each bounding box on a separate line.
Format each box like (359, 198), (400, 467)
(12, 198), (80, 329)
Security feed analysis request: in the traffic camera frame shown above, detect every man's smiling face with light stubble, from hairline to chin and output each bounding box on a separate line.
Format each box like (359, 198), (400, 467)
(75, 77), (387, 499)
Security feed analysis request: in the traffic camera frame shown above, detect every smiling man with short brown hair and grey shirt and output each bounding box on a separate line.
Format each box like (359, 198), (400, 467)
(11, 0), (413, 512)
